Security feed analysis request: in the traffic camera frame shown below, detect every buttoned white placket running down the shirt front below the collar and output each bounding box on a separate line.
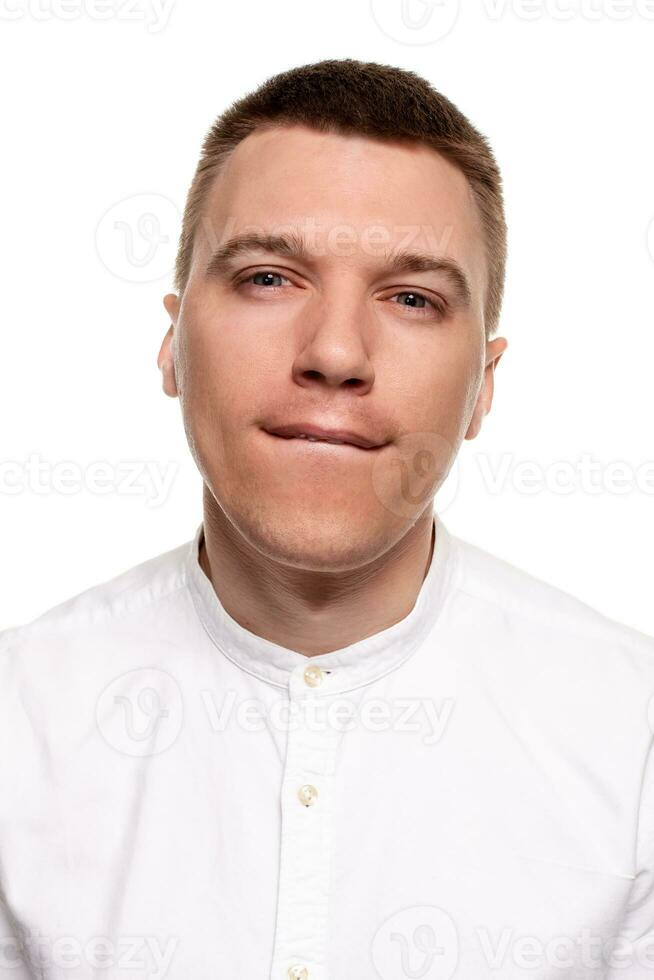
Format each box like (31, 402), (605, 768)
(270, 664), (354, 980)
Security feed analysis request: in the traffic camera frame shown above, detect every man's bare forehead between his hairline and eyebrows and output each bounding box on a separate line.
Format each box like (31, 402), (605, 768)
(204, 125), (485, 283)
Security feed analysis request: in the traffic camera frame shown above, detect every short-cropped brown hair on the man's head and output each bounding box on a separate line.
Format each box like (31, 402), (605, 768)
(175, 58), (507, 338)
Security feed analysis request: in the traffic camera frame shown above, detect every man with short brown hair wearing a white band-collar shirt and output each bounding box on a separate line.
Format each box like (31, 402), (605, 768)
(0, 59), (654, 980)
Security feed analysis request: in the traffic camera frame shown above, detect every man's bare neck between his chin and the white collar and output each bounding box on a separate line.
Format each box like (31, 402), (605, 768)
(199, 487), (435, 657)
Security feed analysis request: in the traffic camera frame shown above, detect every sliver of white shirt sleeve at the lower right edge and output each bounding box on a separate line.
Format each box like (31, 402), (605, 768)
(606, 739), (654, 980)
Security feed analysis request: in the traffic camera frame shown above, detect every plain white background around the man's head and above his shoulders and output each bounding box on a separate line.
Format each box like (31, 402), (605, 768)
(0, 0), (654, 634)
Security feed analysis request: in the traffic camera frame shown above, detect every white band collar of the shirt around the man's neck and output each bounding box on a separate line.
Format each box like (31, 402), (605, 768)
(185, 513), (455, 695)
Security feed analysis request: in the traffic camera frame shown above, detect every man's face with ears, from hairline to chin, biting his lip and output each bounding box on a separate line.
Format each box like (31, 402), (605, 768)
(159, 126), (506, 570)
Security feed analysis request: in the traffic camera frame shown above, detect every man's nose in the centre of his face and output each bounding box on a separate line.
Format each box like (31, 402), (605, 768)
(293, 296), (375, 395)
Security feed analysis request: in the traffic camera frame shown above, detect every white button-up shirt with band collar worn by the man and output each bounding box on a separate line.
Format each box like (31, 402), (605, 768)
(0, 516), (654, 980)
